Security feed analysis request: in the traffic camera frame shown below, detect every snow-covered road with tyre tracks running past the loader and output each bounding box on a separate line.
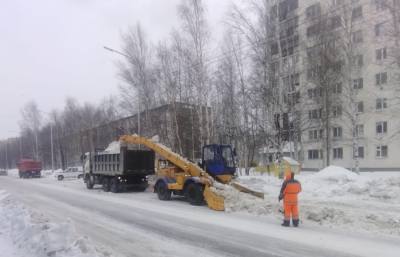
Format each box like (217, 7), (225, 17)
(0, 177), (400, 257)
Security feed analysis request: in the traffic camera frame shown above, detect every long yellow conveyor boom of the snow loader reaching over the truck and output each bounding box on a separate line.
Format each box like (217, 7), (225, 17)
(120, 135), (206, 179)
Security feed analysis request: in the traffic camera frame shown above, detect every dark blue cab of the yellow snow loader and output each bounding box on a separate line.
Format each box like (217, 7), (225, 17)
(202, 144), (236, 177)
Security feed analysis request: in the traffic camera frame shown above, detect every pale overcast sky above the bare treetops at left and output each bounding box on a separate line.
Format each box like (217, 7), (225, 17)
(0, 0), (231, 139)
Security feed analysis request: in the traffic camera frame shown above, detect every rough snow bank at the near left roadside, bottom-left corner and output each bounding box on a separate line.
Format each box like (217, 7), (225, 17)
(0, 191), (109, 257)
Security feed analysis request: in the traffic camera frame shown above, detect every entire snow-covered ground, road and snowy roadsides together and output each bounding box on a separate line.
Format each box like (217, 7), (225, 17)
(0, 167), (400, 257)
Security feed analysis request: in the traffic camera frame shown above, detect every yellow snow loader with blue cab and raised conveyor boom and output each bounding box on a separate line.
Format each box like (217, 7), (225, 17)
(120, 135), (264, 211)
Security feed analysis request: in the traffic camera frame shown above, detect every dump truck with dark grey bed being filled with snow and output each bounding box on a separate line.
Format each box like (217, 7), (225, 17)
(83, 145), (155, 193)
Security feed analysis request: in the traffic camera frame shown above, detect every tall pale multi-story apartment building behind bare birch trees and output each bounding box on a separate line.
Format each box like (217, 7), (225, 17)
(270, 0), (400, 171)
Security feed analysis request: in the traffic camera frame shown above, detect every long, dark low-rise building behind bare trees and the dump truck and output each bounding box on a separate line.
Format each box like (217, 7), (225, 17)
(77, 102), (211, 159)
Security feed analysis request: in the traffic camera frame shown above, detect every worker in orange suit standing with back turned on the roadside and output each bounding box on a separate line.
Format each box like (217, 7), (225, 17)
(279, 172), (301, 227)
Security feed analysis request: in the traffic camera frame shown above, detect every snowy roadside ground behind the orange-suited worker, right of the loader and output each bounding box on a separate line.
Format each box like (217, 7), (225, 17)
(233, 166), (400, 236)
